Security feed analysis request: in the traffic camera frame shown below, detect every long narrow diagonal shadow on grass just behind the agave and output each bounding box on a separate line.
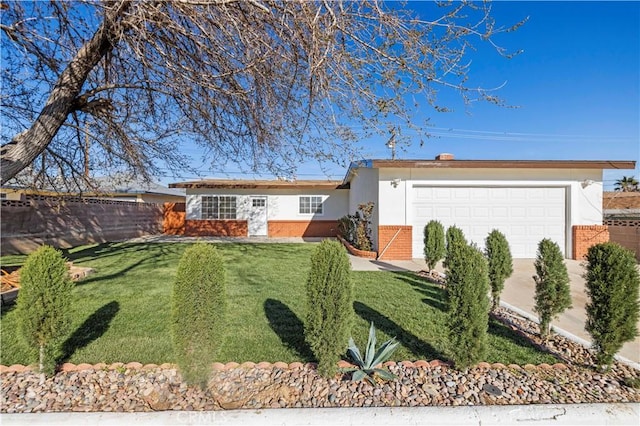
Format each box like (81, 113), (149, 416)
(353, 302), (447, 361)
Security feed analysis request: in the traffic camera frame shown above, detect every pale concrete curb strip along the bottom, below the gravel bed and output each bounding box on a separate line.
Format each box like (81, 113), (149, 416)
(0, 403), (640, 426)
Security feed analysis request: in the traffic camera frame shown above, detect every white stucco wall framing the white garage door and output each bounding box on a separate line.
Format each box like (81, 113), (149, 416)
(372, 168), (602, 256)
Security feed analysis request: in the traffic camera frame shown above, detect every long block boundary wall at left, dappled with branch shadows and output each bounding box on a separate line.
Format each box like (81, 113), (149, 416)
(0, 196), (163, 254)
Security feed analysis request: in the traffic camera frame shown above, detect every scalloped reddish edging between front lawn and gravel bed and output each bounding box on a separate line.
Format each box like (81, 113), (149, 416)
(0, 359), (568, 374)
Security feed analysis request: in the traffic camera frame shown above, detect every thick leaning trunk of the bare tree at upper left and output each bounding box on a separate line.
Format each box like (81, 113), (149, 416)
(0, 1), (131, 185)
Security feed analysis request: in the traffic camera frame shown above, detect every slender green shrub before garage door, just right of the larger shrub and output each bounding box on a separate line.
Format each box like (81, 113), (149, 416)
(485, 229), (513, 309)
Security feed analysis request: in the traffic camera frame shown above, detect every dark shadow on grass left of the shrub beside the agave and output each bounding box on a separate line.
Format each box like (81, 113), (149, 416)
(264, 299), (315, 362)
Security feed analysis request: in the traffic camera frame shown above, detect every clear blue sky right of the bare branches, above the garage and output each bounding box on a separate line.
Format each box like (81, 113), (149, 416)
(163, 2), (640, 190)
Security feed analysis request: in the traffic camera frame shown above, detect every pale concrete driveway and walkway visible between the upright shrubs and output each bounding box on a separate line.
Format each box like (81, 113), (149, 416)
(349, 255), (640, 364)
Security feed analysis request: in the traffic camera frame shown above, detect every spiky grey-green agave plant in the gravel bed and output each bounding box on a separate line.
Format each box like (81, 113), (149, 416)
(342, 322), (399, 385)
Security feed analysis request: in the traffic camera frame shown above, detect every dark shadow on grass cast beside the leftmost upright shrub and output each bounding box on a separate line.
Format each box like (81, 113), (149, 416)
(58, 301), (120, 364)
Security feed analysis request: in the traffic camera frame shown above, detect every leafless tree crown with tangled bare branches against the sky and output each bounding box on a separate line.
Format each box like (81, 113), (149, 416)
(0, 0), (521, 190)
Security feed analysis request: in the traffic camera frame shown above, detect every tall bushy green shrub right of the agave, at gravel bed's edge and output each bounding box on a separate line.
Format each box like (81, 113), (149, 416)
(446, 244), (489, 368)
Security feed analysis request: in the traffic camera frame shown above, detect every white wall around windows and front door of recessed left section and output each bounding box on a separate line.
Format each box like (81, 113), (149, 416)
(186, 188), (349, 220)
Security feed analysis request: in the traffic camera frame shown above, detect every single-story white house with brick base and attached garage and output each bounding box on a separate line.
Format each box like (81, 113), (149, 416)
(169, 154), (635, 260)
